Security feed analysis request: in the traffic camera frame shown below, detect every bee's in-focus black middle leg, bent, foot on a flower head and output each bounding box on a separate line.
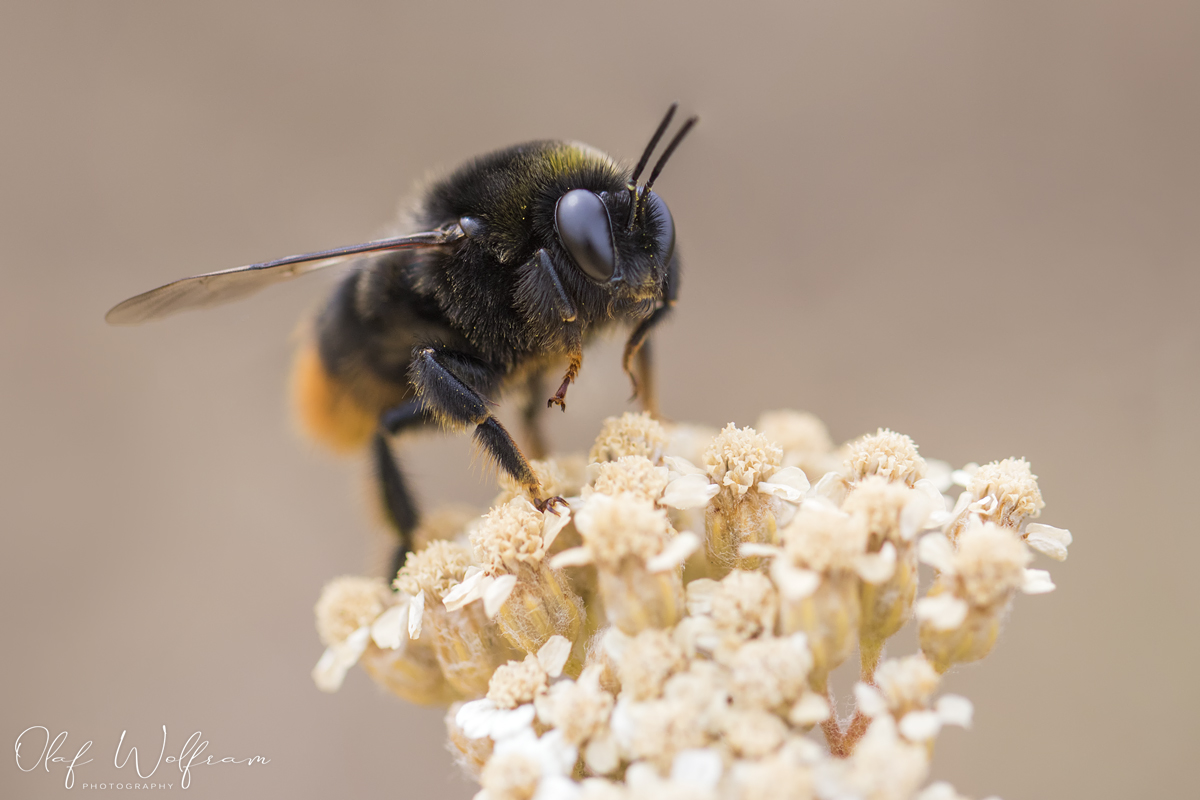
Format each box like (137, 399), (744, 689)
(400, 345), (562, 510)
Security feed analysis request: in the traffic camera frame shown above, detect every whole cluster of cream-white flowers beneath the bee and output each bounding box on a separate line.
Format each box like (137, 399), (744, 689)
(313, 411), (1070, 800)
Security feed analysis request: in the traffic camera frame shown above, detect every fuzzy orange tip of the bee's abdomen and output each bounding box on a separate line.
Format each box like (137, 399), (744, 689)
(292, 343), (378, 452)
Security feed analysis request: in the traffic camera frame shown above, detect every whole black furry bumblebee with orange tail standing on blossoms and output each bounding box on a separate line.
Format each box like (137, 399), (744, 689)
(106, 104), (696, 567)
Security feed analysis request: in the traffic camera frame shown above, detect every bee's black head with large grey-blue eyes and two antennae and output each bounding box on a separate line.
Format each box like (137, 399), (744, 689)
(554, 104), (696, 305)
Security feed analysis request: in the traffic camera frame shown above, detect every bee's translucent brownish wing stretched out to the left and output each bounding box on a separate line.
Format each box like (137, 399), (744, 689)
(104, 224), (463, 325)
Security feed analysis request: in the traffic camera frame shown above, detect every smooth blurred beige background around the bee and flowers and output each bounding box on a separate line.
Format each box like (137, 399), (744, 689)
(0, 0), (1200, 800)
